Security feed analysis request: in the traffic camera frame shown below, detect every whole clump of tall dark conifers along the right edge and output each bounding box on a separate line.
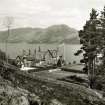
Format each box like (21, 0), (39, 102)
(75, 7), (105, 89)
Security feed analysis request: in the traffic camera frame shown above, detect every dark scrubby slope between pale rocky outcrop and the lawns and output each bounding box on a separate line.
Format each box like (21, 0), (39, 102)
(1, 71), (105, 105)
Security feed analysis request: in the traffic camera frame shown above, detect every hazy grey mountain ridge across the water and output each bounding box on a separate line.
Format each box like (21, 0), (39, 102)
(0, 24), (79, 44)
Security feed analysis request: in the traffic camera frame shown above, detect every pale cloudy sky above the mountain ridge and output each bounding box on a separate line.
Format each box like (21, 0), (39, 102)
(0, 0), (105, 30)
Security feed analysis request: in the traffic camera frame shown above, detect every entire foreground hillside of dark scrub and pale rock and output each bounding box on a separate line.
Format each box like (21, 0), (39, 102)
(0, 70), (105, 105)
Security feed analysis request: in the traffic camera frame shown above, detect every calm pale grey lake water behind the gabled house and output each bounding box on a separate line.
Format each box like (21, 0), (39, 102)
(0, 43), (82, 63)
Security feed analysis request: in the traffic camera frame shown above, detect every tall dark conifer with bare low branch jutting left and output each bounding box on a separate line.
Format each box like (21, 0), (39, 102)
(75, 9), (99, 88)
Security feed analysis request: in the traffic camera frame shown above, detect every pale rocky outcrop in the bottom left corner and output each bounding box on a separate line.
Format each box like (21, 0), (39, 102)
(0, 78), (39, 105)
